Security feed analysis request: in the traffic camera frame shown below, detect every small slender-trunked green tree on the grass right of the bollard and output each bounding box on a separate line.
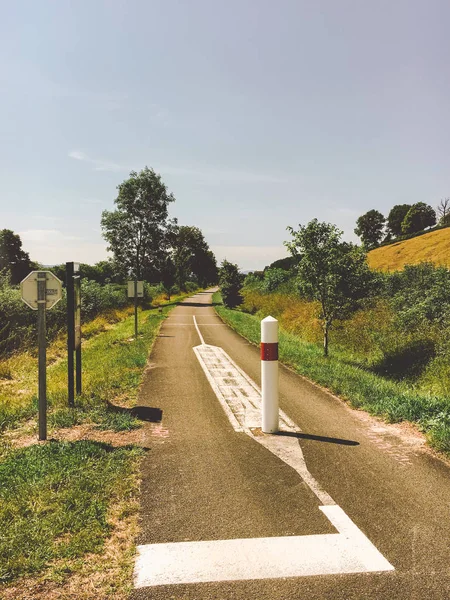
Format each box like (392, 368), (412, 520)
(285, 219), (373, 356)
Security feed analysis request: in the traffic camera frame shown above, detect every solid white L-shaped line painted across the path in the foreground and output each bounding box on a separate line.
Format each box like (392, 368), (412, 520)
(135, 505), (393, 588)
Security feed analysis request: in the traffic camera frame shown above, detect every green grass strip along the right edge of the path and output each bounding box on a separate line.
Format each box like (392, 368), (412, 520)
(213, 293), (450, 453)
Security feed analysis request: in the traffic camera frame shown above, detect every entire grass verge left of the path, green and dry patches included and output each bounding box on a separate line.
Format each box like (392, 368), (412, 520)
(0, 290), (193, 600)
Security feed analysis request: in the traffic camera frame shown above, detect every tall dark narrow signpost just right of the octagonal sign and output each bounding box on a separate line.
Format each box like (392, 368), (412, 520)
(66, 262), (81, 407)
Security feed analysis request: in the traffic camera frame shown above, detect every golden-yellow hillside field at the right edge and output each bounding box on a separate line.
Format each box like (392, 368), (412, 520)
(367, 228), (450, 271)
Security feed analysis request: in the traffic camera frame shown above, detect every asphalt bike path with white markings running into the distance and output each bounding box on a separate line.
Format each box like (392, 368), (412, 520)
(133, 293), (450, 600)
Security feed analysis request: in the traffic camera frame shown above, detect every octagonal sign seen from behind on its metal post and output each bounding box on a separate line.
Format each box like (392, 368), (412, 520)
(20, 271), (62, 440)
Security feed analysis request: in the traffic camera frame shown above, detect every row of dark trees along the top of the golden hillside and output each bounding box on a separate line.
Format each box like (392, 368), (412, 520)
(355, 198), (450, 250)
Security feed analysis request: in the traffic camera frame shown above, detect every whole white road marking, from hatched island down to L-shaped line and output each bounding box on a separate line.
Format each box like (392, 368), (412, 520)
(134, 340), (394, 588)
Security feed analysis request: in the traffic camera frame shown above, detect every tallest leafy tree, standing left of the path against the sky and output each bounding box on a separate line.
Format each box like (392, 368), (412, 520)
(101, 167), (175, 279)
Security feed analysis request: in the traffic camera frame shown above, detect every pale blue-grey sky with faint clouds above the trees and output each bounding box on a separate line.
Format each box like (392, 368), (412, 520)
(0, 0), (450, 269)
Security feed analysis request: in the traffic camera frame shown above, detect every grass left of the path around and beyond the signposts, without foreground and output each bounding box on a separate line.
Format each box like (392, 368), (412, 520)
(0, 298), (185, 431)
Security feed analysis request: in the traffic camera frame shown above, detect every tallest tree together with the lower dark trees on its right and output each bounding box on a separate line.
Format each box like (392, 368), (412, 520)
(101, 167), (218, 294)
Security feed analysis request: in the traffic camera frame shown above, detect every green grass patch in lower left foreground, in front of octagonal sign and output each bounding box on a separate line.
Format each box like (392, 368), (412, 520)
(0, 441), (142, 582)
